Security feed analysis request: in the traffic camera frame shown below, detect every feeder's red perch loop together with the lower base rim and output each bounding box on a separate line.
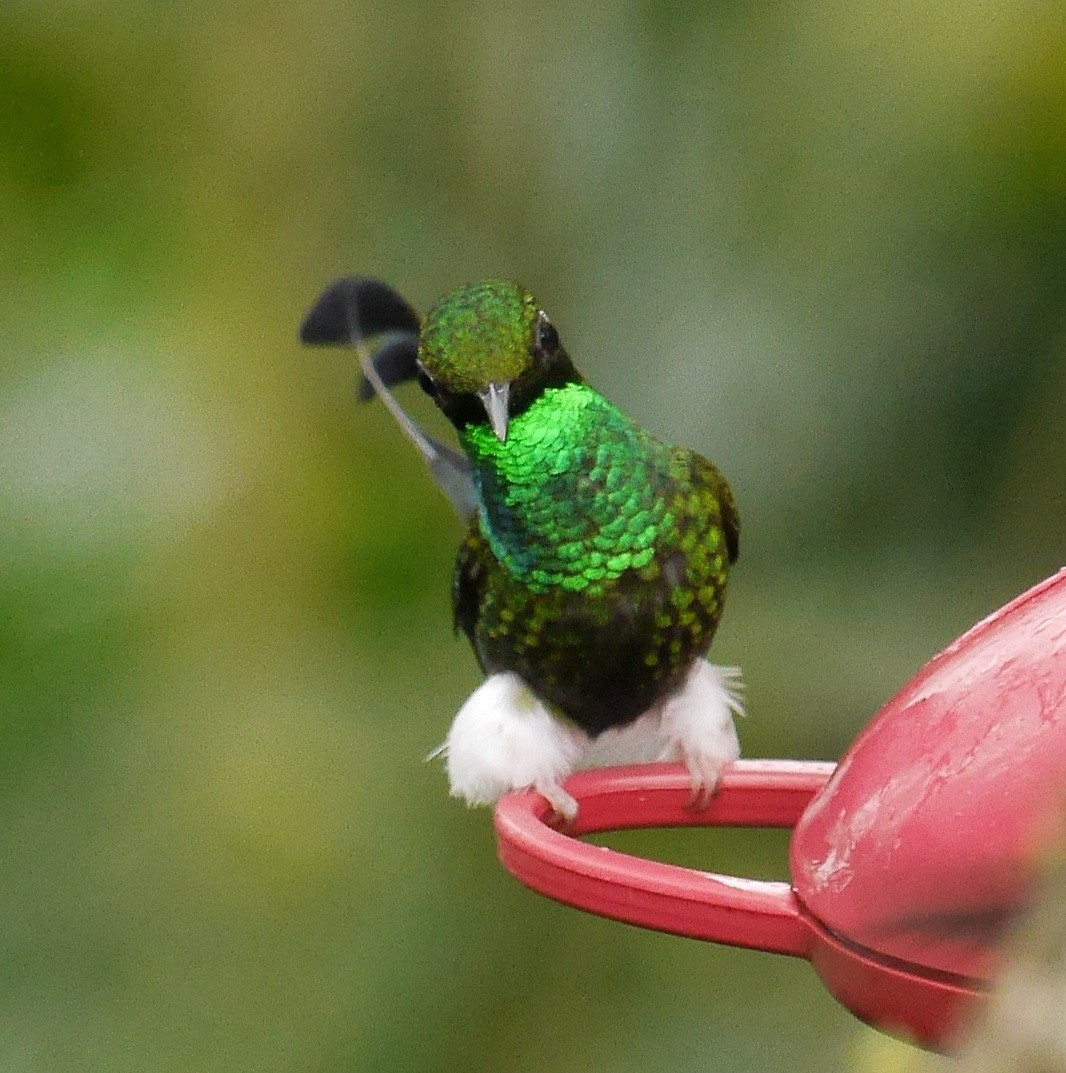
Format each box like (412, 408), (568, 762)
(496, 760), (980, 1046)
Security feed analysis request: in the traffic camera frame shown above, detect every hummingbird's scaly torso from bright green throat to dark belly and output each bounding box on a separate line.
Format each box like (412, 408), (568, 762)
(454, 383), (739, 733)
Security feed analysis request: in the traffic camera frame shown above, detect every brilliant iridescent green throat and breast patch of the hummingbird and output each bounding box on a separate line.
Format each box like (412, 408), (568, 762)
(459, 384), (676, 592)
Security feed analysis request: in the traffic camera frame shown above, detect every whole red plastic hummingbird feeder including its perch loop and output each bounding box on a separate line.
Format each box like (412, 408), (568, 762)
(496, 570), (1066, 1048)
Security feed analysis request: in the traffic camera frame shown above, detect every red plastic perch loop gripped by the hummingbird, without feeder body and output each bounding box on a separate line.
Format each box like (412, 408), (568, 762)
(496, 760), (833, 957)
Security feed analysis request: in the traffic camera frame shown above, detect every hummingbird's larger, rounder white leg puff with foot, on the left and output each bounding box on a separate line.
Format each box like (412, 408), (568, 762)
(429, 672), (588, 820)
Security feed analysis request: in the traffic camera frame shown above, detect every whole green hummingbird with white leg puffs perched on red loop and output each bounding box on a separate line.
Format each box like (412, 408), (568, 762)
(301, 277), (743, 821)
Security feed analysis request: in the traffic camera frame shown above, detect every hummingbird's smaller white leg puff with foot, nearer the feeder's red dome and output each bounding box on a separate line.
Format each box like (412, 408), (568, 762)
(660, 660), (744, 807)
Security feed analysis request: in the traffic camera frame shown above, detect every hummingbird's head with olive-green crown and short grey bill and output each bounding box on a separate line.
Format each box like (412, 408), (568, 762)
(419, 279), (580, 441)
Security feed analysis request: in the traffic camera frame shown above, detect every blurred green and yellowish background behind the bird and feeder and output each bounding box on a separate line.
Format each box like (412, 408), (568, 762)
(0, 0), (1066, 1073)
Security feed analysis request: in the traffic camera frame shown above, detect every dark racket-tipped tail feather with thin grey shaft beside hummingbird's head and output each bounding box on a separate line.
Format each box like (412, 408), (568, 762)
(300, 276), (478, 518)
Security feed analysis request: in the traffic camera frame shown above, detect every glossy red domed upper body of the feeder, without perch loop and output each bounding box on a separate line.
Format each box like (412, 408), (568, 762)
(791, 571), (1066, 978)
